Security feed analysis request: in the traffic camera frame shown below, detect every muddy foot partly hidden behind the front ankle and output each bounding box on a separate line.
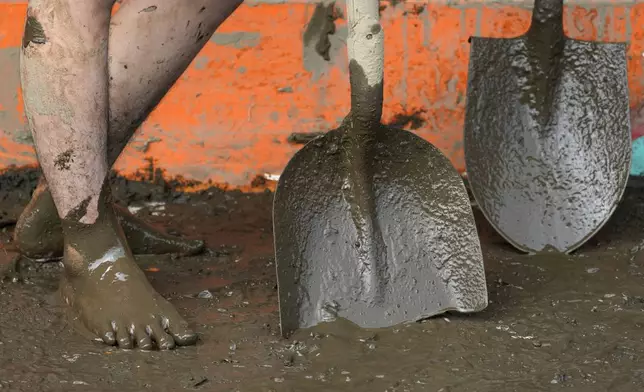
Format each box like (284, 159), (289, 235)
(14, 181), (205, 260)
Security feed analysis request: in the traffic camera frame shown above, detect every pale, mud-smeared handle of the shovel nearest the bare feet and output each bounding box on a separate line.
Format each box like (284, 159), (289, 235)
(347, 0), (385, 125)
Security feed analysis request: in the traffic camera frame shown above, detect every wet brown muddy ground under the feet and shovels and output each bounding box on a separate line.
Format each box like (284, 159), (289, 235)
(0, 172), (644, 392)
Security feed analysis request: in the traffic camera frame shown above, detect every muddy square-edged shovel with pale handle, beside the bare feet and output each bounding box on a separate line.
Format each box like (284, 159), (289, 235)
(273, 0), (487, 337)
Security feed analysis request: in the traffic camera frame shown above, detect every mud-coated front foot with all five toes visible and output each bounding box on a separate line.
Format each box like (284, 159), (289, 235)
(61, 199), (197, 350)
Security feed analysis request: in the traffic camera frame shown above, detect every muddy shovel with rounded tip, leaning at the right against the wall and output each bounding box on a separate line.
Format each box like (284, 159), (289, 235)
(464, 0), (631, 253)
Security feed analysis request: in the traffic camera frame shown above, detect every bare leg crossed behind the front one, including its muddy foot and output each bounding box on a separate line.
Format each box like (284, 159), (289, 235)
(14, 0), (242, 260)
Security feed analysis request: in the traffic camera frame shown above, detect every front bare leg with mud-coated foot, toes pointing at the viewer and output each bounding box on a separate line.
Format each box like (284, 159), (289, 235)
(21, 0), (197, 349)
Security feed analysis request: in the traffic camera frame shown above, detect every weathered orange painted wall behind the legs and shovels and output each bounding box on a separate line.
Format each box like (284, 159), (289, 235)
(0, 1), (644, 186)
